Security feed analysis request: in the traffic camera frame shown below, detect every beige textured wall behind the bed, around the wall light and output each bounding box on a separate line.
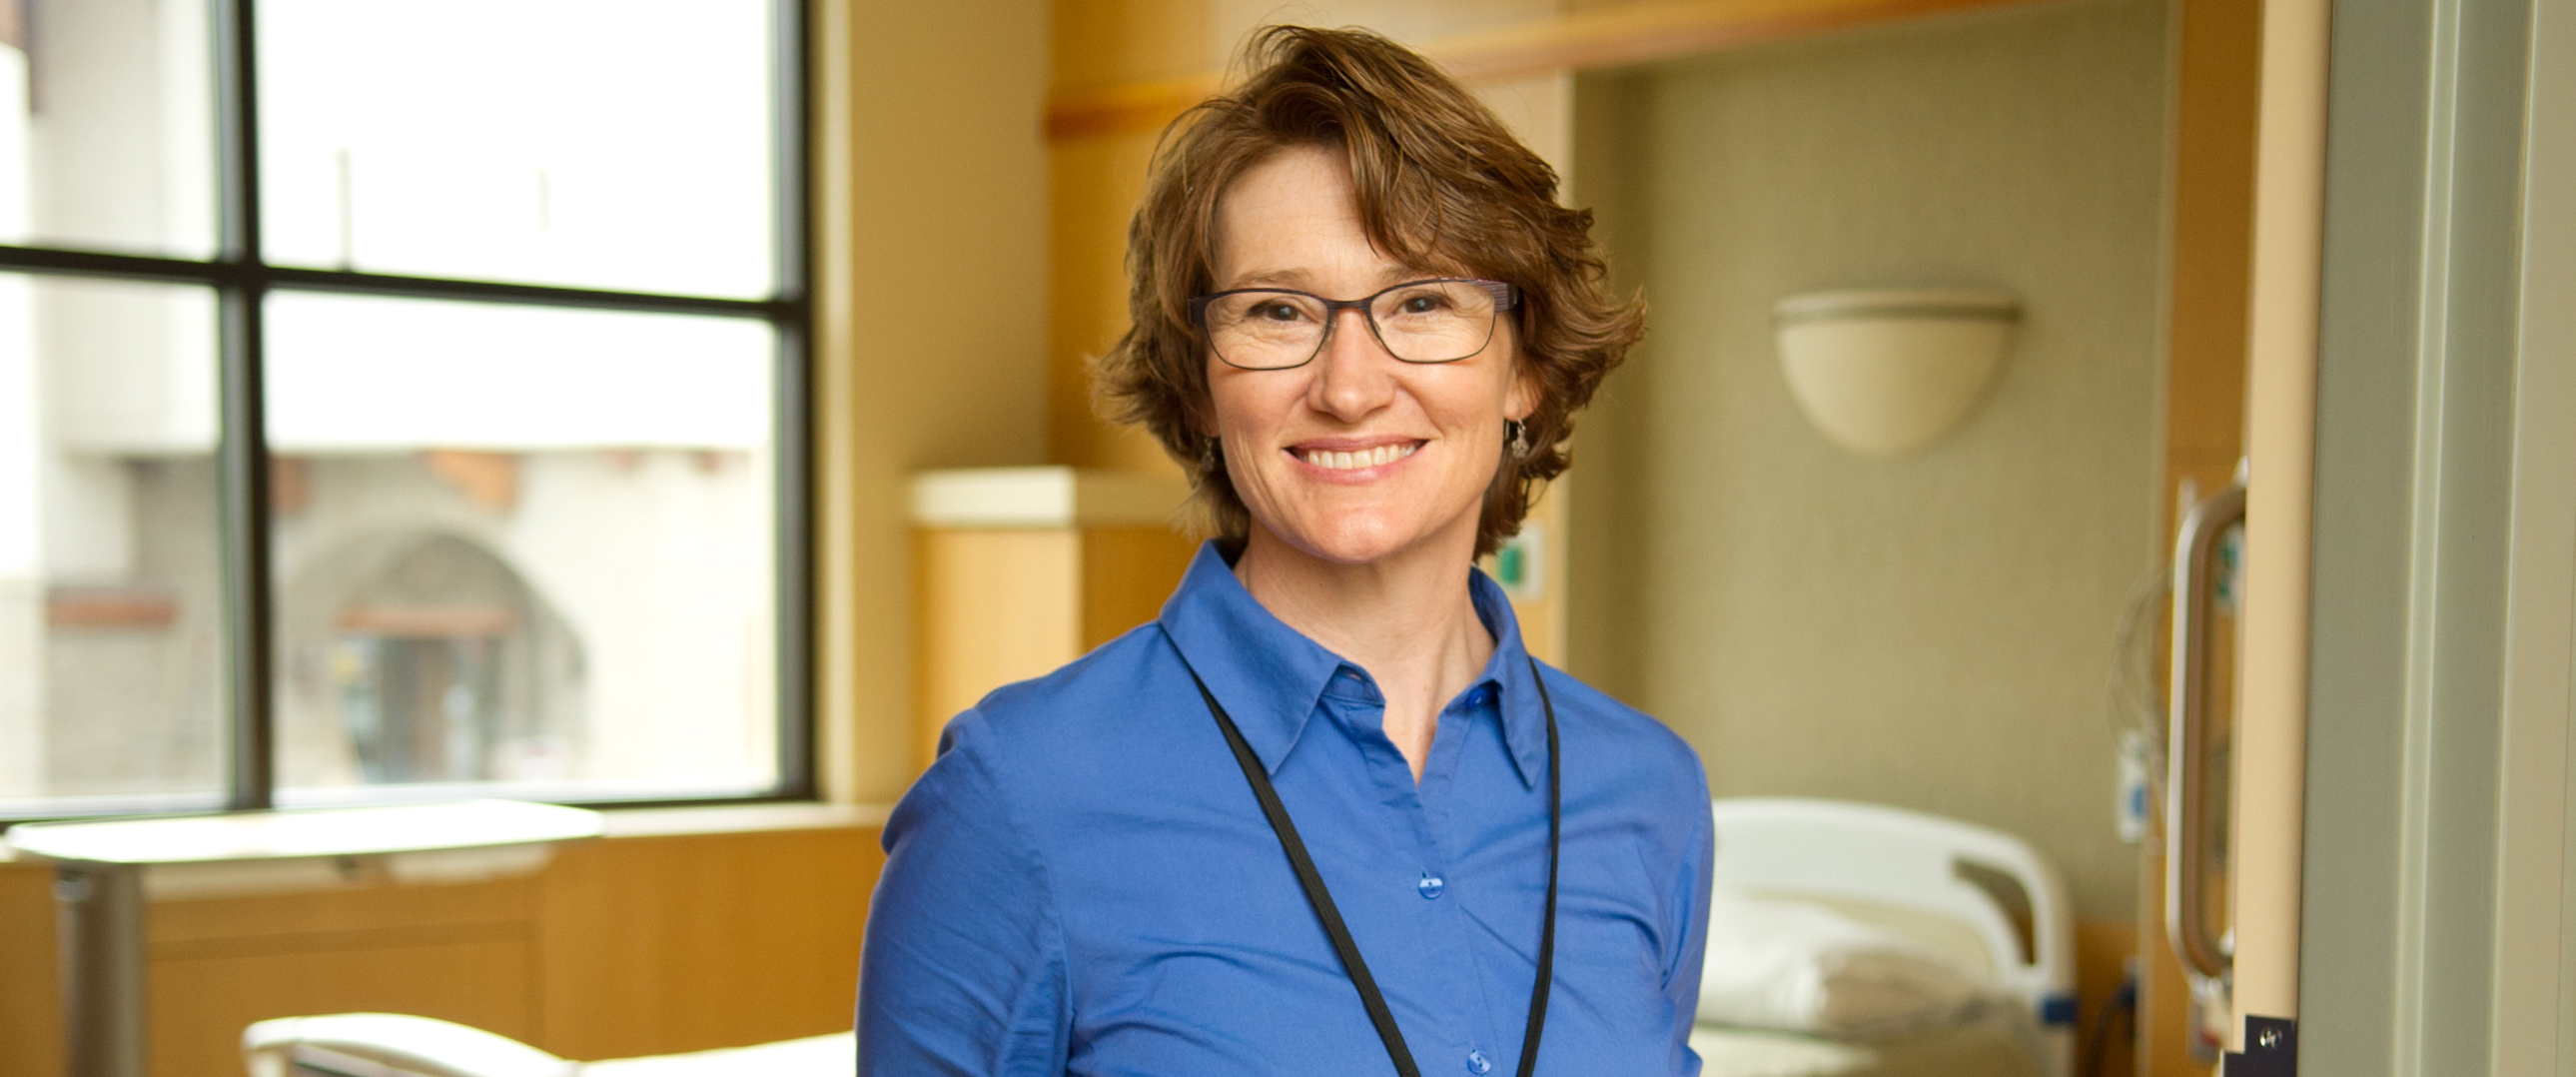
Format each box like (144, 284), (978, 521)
(1574, 0), (2166, 917)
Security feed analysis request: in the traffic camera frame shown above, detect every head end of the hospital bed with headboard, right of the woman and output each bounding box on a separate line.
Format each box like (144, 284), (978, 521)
(1690, 798), (2077, 1077)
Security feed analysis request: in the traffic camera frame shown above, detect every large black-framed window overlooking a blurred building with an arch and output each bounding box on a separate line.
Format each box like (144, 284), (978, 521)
(0, 0), (811, 819)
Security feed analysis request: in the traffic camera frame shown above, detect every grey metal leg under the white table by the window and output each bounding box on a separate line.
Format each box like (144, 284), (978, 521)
(54, 863), (144, 1077)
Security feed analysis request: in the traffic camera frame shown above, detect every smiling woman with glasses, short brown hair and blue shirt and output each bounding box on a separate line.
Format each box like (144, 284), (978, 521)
(858, 28), (1710, 1077)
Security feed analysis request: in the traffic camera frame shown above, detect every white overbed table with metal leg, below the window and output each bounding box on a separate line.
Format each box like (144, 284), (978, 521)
(8, 801), (602, 1077)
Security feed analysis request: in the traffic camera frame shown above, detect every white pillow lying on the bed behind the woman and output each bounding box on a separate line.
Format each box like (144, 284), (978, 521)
(1700, 884), (1989, 1038)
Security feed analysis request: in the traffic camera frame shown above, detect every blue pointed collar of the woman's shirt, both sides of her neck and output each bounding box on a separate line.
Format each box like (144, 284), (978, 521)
(1162, 538), (1548, 786)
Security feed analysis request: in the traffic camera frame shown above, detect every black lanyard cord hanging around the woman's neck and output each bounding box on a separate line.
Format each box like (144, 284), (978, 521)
(1190, 659), (1566, 1077)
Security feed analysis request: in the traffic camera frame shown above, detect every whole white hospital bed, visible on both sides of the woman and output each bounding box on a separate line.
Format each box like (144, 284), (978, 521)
(242, 798), (2074, 1077)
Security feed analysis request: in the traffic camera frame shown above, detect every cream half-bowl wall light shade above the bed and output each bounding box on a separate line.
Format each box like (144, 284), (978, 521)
(1772, 289), (2023, 456)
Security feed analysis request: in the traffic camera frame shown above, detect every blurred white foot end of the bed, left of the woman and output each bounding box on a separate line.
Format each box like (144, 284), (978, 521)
(242, 1013), (858, 1077)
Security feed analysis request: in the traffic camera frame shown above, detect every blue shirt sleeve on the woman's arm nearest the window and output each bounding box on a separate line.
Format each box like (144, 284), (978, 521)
(858, 711), (1072, 1077)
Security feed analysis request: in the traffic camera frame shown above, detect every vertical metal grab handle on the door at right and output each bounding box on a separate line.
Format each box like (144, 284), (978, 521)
(2163, 477), (2246, 979)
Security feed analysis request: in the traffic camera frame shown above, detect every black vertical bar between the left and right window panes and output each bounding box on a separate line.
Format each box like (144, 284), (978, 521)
(214, 0), (276, 811)
